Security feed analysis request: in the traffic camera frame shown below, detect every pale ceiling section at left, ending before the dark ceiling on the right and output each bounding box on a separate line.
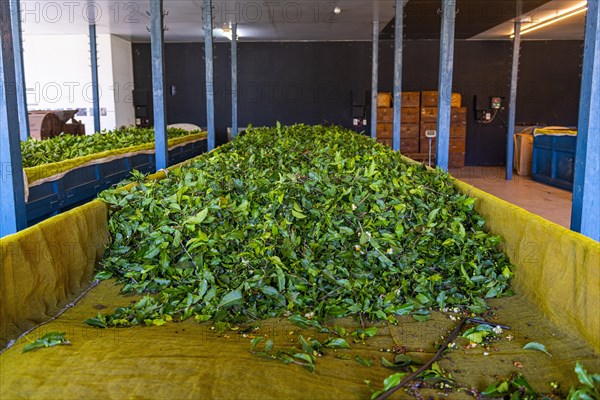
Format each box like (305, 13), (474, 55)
(22, 0), (394, 42)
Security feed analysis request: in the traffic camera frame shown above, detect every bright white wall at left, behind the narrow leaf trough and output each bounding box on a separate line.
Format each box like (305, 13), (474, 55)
(23, 35), (134, 134)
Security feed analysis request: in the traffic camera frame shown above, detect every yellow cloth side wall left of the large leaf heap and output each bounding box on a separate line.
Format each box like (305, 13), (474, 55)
(0, 200), (108, 347)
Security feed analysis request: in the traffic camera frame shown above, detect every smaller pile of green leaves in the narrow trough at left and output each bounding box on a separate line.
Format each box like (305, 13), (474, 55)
(21, 127), (199, 168)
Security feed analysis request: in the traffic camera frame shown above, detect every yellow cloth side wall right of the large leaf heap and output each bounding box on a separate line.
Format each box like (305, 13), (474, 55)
(455, 180), (600, 352)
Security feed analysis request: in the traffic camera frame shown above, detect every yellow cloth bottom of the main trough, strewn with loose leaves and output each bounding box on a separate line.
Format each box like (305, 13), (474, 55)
(0, 282), (599, 400)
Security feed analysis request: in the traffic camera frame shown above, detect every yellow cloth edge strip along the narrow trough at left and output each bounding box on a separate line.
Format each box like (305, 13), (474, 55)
(24, 132), (207, 184)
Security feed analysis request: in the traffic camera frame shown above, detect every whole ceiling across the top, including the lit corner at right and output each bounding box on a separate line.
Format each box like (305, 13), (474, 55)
(21, 0), (585, 42)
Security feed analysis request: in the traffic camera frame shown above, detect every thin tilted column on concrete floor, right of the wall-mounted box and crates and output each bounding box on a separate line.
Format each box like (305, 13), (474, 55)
(506, 0), (523, 181)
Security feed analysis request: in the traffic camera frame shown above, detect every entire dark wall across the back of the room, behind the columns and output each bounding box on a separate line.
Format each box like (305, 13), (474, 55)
(133, 40), (582, 165)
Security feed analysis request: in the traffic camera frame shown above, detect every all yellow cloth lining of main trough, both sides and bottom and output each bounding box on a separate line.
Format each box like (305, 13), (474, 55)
(0, 152), (600, 399)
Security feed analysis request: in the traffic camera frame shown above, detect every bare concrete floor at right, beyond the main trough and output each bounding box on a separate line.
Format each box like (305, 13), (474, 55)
(450, 167), (572, 228)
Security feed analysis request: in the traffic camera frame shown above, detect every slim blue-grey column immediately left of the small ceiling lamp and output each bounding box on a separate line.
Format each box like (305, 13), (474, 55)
(204, 0), (215, 151)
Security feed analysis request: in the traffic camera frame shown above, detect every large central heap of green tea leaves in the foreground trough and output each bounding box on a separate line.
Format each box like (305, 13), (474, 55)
(92, 124), (512, 327)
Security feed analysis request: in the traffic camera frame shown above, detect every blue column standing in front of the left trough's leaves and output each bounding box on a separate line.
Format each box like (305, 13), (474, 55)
(150, 0), (169, 171)
